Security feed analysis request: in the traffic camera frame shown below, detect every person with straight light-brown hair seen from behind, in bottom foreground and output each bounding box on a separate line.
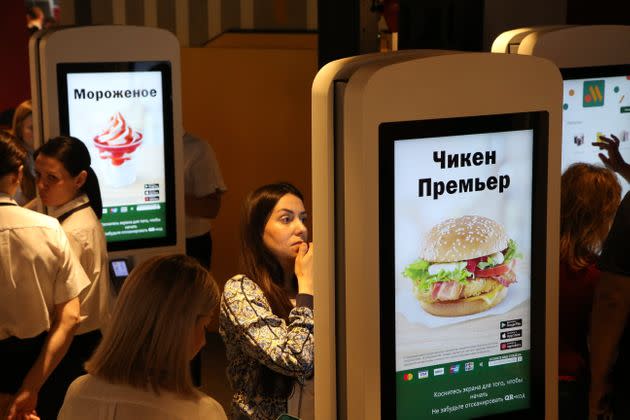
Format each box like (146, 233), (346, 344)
(58, 255), (226, 420)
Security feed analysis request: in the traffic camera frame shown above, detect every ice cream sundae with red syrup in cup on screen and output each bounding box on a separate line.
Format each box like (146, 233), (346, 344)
(94, 112), (143, 187)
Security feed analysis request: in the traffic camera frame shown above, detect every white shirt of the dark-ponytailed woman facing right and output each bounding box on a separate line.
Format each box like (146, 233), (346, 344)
(44, 194), (114, 334)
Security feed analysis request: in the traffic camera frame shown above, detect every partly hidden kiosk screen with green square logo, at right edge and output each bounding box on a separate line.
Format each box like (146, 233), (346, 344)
(562, 65), (630, 197)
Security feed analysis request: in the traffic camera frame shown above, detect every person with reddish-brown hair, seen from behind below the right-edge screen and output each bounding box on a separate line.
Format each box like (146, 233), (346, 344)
(559, 163), (621, 419)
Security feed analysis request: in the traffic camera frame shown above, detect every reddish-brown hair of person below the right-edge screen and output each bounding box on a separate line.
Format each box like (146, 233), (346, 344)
(560, 163), (621, 271)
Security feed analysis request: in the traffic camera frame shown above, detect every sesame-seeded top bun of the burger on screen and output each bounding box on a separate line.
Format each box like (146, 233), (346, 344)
(420, 216), (509, 262)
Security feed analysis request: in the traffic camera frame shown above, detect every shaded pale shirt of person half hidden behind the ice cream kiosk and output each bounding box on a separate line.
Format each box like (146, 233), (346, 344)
(184, 133), (227, 238)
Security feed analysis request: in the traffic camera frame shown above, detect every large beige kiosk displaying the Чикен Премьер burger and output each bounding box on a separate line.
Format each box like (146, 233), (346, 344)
(312, 51), (562, 420)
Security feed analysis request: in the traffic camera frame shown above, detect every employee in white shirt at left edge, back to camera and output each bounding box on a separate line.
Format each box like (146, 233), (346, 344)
(0, 131), (89, 419)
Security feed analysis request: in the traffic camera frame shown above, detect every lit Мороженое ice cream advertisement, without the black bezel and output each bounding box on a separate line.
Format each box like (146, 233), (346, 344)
(66, 71), (166, 241)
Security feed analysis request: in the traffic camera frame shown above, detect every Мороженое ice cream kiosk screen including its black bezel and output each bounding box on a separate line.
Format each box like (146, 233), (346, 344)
(57, 62), (175, 250)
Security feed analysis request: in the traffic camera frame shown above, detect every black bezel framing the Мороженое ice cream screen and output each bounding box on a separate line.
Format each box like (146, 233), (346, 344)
(57, 61), (177, 252)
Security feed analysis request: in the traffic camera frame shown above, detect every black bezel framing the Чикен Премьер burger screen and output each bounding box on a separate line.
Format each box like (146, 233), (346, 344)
(379, 111), (549, 420)
